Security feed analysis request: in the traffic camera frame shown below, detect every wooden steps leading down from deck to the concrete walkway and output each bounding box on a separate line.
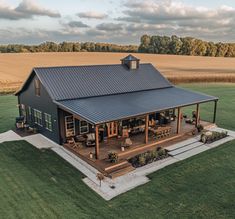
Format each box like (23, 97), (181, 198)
(105, 160), (135, 179)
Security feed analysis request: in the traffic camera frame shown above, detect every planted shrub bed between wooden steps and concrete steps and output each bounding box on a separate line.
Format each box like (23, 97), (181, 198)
(128, 147), (169, 168)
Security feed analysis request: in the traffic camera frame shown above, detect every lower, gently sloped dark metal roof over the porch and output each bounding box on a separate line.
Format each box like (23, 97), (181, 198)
(55, 87), (218, 124)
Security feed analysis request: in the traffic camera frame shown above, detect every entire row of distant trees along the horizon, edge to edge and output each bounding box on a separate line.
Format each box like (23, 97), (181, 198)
(0, 35), (235, 57)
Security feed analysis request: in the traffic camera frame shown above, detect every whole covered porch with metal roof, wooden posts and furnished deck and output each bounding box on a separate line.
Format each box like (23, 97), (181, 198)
(57, 87), (218, 175)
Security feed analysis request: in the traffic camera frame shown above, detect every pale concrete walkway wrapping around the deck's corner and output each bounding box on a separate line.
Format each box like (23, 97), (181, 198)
(0, 128), (235, 200)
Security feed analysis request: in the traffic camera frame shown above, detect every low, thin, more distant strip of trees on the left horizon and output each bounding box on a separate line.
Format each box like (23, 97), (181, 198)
(0, 42), (138, 53)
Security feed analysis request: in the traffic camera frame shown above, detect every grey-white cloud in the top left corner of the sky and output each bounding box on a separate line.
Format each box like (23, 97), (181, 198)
(0, 0), (60, 20)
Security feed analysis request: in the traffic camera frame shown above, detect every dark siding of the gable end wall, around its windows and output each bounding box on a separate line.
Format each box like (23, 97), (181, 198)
(18, 72), (60, 143)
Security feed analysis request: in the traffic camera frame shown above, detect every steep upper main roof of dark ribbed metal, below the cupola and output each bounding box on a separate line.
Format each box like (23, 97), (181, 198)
(34, 64), (172, 100)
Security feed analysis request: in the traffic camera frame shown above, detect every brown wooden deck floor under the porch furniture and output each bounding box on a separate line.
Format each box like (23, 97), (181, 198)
(63, 121), (213, 174)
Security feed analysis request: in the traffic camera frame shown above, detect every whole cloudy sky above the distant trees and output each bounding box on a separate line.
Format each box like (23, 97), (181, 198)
(0, 0), (235, 44)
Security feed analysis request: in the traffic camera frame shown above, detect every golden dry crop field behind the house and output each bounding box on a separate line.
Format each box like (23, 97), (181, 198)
(0, 52), (235, 92)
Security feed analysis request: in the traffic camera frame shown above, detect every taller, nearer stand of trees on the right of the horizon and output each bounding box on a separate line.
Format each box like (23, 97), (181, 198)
(138, 35), (235, 57)
